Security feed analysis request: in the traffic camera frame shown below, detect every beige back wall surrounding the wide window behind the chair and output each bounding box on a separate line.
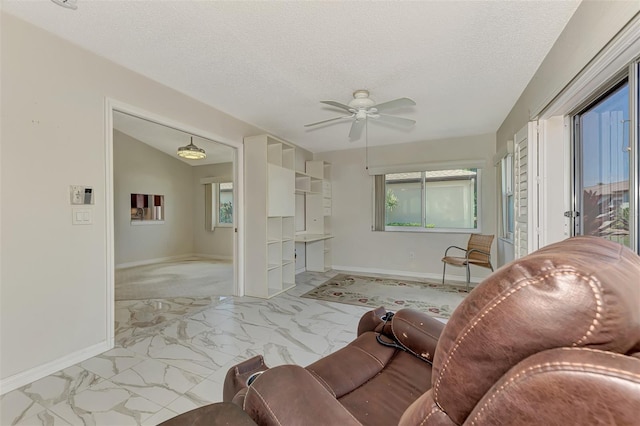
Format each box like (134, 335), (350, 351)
(316, 135), (496, 280)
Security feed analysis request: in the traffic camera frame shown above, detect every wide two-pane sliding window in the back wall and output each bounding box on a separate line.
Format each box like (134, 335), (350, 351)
(375, 168), (480, 232)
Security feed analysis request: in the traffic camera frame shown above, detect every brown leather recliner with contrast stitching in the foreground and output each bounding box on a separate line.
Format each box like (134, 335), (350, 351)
(224, 237), (640, 425)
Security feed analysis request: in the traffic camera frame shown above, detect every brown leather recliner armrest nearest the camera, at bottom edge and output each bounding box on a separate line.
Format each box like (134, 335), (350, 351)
(244, 365), (360, 426)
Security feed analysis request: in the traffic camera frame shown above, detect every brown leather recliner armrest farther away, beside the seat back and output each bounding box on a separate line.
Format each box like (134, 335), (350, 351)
(391, 309), (444, 362)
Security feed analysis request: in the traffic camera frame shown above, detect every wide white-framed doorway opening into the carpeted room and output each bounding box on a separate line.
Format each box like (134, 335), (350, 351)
(107, 102), (243, 341)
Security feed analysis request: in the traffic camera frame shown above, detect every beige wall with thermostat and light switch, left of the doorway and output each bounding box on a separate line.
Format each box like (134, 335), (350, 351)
(0, 12), (263, 391)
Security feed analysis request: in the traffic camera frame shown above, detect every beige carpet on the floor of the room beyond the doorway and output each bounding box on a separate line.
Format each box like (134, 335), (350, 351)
(115, 259), (233, 300)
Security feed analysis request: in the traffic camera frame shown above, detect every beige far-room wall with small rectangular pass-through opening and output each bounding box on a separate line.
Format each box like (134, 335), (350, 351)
(113, 131), (195, 267)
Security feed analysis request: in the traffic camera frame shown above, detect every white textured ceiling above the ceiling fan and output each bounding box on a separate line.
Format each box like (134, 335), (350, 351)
(2, 0), (579, 152)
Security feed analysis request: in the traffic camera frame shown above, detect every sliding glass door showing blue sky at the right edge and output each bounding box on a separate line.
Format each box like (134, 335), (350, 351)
(573, 78), (638, 249)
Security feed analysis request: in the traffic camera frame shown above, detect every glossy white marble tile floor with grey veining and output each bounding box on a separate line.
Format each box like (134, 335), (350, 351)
(0, 271), (369, 426)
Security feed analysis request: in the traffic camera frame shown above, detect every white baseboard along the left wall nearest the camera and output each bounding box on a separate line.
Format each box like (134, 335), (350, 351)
(0, 341), (113, 395)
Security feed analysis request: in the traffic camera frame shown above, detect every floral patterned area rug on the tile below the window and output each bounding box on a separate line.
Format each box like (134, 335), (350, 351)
(302, 274), (468, 318)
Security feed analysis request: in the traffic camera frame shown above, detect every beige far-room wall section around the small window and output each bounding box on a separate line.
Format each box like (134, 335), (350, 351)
(192, 163), (237, 259)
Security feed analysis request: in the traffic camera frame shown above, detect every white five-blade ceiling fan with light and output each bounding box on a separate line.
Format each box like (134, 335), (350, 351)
(304, 90), (416, 140)
